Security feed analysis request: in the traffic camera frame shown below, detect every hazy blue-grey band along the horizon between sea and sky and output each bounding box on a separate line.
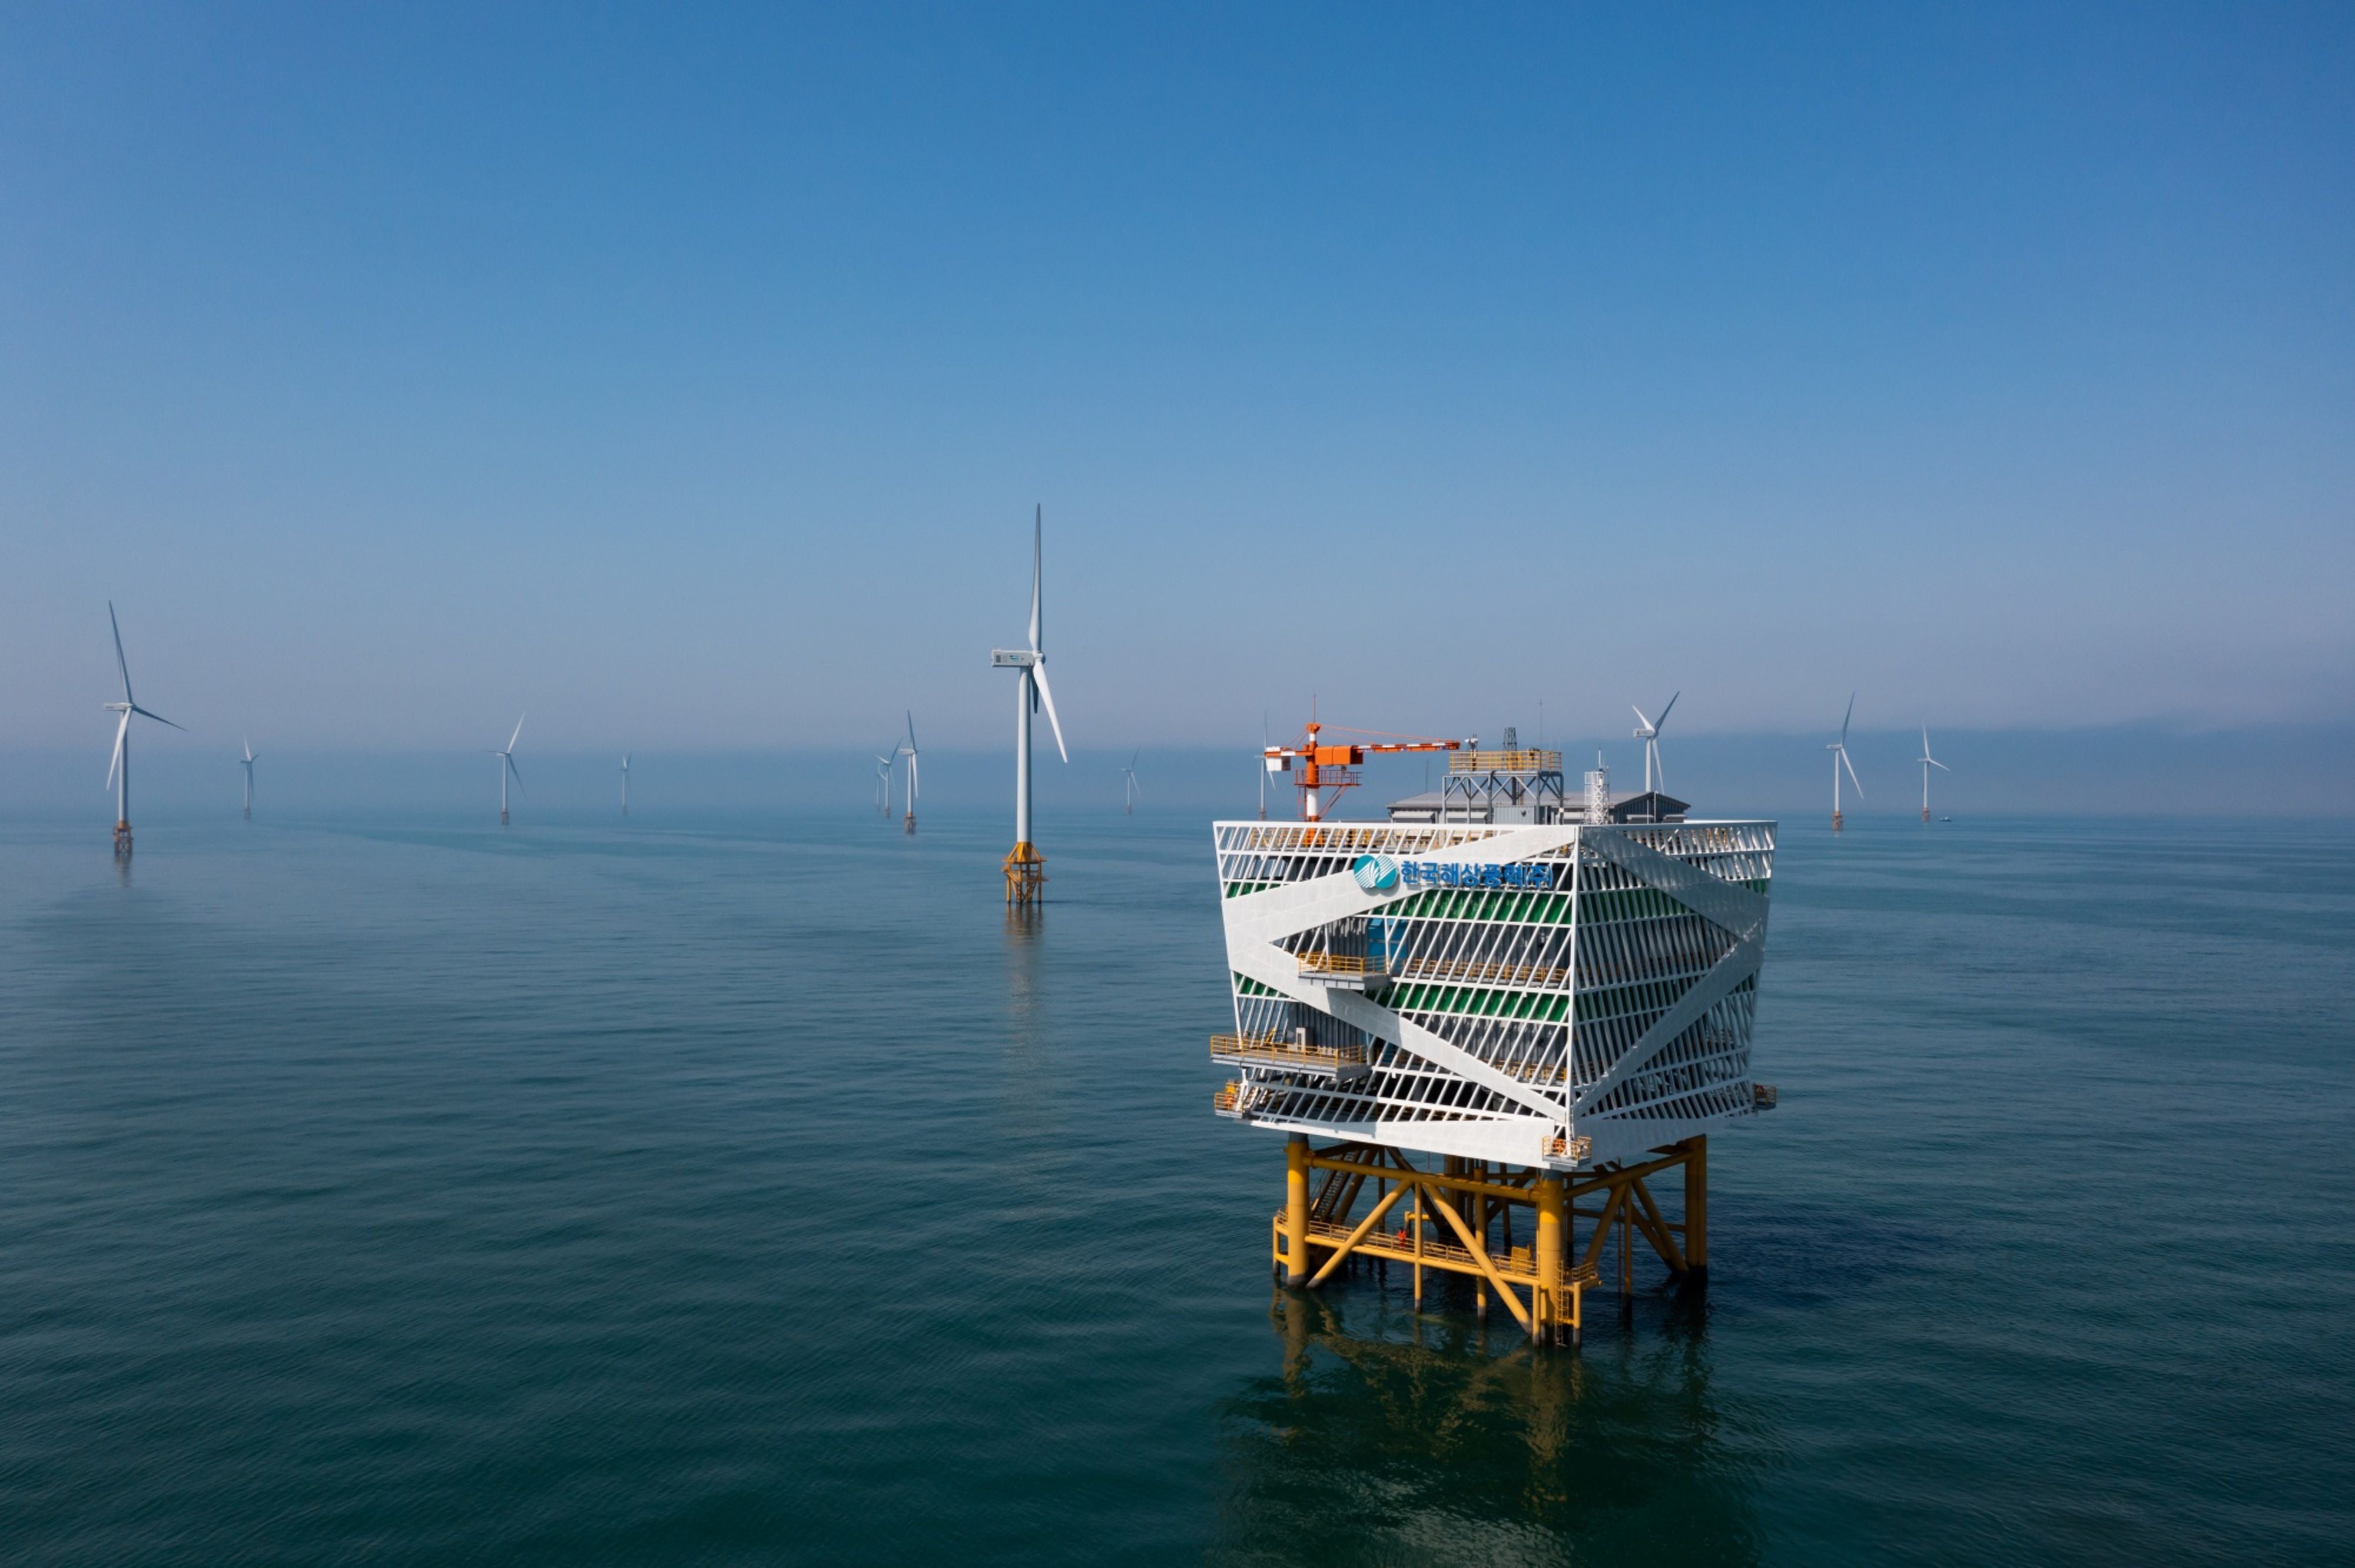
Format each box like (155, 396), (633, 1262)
(0, 725), (2355, 819)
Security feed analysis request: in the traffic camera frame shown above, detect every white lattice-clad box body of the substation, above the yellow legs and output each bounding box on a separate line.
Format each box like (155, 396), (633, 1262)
(1210, 822), (1773, 1170)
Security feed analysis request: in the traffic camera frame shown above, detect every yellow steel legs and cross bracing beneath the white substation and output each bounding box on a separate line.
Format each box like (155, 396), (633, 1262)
(1272, 1135), (1710, 1342)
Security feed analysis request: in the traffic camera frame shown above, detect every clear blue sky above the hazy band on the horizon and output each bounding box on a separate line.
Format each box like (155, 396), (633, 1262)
(0, 5), (2355, 756)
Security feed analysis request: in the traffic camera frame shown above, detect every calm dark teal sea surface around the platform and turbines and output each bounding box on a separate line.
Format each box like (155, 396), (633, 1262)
(0, 810), (2355, 1563)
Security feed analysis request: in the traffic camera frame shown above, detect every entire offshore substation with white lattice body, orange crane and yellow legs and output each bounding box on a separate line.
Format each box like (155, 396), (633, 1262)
(1210, 730), (1776, 1342)
